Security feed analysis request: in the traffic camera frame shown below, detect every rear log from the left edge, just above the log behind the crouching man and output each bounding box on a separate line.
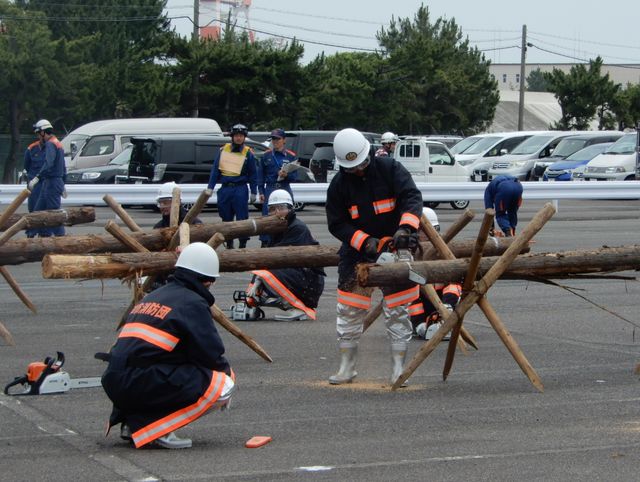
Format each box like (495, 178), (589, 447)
(0, 216), (287, 266)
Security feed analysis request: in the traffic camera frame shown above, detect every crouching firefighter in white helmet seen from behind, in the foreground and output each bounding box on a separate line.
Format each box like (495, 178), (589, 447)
(101, 243), (235, 449)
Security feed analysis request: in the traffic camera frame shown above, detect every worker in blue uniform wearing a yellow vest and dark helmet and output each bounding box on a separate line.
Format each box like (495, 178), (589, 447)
(208, 124), (257, 249)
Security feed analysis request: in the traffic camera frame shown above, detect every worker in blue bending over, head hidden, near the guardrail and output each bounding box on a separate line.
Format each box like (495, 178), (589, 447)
(484, 176), (522, 236)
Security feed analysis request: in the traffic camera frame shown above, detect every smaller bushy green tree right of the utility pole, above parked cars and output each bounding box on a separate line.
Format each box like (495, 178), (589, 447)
(544, 57), (620, 130)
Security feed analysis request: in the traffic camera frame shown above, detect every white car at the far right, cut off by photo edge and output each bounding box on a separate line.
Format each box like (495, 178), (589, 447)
(584, 132), (638, 181)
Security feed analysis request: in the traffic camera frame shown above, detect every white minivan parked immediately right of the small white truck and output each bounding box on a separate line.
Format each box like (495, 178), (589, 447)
(456, 131), (540, 181)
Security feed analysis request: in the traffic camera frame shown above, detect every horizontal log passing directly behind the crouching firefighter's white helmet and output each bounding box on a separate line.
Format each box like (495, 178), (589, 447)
(42, 239), (528, 279)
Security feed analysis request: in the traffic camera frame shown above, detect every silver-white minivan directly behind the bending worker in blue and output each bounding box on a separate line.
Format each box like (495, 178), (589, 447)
(487, 131), (575, 181)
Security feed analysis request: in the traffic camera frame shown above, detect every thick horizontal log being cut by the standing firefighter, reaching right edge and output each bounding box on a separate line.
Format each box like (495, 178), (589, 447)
(358, 245), (640, 286)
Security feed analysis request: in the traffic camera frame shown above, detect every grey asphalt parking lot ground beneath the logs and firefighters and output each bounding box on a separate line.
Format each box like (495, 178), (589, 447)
(0, 200), (640, 481)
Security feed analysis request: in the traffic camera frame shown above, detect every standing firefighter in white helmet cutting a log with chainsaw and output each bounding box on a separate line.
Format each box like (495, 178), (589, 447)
(326, 128), (422, 385)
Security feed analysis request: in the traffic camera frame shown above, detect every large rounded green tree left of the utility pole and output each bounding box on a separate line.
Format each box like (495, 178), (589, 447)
(377, 6), (499, 133)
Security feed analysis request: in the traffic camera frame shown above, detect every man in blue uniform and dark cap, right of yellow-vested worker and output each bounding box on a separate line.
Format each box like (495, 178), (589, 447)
(258, 129), (298, 246)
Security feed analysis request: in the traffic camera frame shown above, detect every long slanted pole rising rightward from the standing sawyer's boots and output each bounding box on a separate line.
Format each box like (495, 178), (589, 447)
(391, 203), (556, 390)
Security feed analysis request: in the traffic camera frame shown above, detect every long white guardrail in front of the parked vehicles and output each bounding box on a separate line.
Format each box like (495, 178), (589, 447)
(0, 181), (640, 206)
